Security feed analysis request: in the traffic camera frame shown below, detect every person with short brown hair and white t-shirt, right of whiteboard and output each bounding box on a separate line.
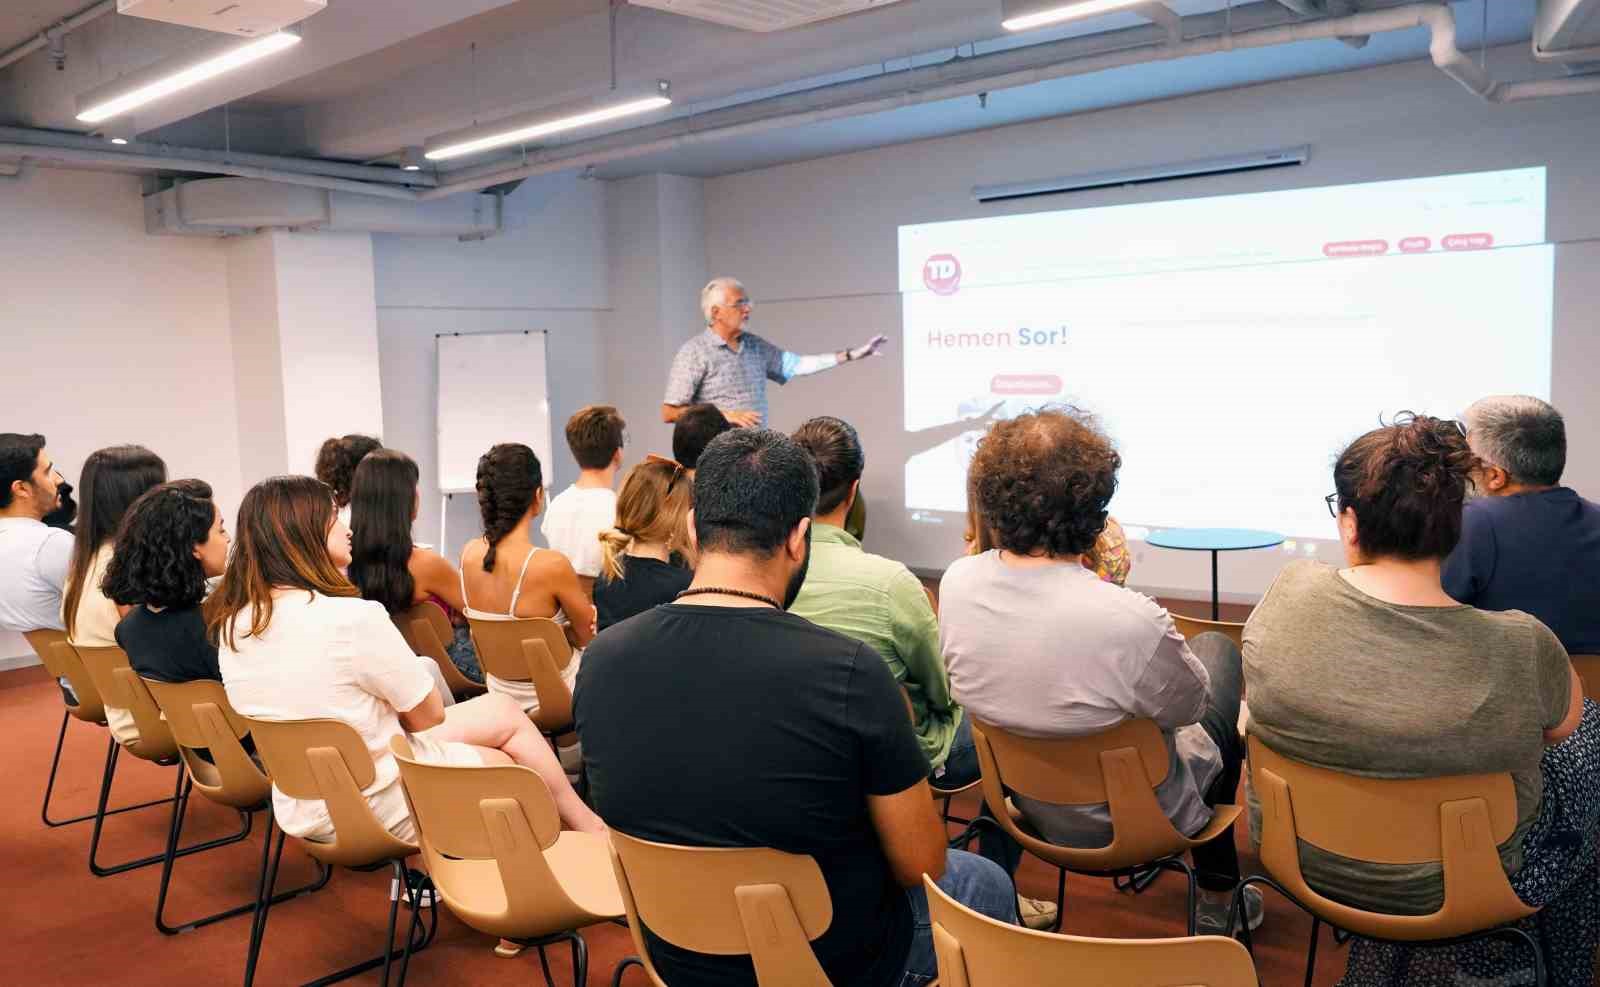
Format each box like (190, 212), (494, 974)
(539, 405), (627, 592)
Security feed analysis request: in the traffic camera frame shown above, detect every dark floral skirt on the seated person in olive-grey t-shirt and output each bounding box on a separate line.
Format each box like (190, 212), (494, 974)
(1339, 699), (1600, 987)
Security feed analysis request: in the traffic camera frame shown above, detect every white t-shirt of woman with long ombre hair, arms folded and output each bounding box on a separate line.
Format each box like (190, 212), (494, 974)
(218, 590), (482, 840)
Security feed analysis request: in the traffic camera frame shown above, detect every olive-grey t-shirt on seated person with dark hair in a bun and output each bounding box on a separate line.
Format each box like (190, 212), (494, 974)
(1245, 561), (1571, 915)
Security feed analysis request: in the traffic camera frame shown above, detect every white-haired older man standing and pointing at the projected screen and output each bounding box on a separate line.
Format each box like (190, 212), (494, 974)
(661, 278), (888, 429)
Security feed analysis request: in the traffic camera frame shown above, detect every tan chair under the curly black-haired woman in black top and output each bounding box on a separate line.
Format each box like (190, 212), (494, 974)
(139, 677), (333, 936)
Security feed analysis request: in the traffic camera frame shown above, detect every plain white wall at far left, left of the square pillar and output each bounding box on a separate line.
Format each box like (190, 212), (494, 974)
(0, 170), (243, 657)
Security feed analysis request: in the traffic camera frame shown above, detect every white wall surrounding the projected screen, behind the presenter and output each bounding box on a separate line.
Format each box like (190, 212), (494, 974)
(706, 48), (1600, 600)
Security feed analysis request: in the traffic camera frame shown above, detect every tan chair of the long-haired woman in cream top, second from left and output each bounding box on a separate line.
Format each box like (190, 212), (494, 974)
(72, 646), (250, 877)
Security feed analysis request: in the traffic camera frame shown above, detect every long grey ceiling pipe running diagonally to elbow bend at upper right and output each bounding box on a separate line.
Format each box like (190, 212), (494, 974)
(419, 3), (1600, 200)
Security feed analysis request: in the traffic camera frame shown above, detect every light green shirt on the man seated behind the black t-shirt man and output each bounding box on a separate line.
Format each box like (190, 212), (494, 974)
(789, 523), (962, 771)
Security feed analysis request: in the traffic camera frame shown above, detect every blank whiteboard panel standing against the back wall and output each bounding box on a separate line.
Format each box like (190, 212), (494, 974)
(435, 331), (552, 494)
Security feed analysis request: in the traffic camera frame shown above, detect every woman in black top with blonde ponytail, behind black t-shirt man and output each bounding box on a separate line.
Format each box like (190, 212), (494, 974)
(595, 456), (694, 630)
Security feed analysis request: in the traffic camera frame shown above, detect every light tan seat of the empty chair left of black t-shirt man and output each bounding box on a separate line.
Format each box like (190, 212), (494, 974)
(429, 830), (622, 939)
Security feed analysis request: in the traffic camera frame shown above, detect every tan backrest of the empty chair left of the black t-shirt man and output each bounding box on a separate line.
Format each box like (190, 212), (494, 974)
(389, 736), (608, 934)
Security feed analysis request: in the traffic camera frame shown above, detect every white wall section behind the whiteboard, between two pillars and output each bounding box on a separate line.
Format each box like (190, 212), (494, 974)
(373, 169), (610, 557)
